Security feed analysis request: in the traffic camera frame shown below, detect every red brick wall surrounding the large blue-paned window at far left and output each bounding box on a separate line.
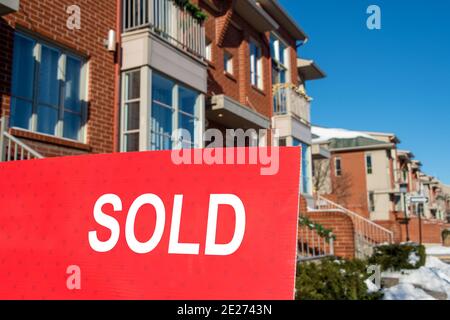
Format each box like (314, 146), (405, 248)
(0, 0), (116, 156)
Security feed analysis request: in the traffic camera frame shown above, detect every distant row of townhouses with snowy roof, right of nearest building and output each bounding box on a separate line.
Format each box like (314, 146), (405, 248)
(312, 127), (450, 244)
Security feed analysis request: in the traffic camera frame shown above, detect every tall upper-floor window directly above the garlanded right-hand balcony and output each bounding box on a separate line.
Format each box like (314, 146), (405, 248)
(270, 35), (289, 84)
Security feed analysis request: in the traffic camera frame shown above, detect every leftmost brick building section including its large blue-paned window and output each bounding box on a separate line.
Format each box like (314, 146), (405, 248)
(0, 0), (117, 156)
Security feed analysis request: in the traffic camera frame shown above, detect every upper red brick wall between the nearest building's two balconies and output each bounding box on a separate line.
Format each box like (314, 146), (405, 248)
(200, 0), (272, 118)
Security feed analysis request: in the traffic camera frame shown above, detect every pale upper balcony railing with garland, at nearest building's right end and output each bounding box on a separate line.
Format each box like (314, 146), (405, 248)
(273, 84), (311, 124)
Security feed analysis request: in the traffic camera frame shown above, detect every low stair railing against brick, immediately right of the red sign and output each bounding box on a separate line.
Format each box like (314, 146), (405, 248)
(297, 226), (334, 262)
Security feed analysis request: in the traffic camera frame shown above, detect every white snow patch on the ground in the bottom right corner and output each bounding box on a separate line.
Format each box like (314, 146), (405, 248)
(383, 256), (450, 300)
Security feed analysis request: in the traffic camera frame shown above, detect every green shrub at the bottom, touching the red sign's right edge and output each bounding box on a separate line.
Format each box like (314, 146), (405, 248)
(296, 258), (382, 300)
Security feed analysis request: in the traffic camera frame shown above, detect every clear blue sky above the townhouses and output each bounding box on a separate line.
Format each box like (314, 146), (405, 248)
(279, 0), (450, 184)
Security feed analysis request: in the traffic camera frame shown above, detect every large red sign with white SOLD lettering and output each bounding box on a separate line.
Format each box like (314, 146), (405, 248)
(0, 148), (300, 300)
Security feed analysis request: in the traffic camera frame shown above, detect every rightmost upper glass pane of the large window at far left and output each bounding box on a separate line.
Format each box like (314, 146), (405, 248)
(64, 57), (82, 113)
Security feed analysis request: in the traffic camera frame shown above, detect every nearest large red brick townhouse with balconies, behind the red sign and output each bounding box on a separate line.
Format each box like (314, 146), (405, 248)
(0, 0), (325, 199)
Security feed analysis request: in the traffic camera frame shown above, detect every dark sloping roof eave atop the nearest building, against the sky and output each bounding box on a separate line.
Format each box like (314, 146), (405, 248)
(256, 0), (308, 41)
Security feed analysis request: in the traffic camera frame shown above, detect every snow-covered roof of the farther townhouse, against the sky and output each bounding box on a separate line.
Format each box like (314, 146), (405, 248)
(312, 126), (393, 151)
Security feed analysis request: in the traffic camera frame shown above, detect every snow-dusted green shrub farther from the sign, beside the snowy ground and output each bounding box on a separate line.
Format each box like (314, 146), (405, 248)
(369, 243), (426, 271)
